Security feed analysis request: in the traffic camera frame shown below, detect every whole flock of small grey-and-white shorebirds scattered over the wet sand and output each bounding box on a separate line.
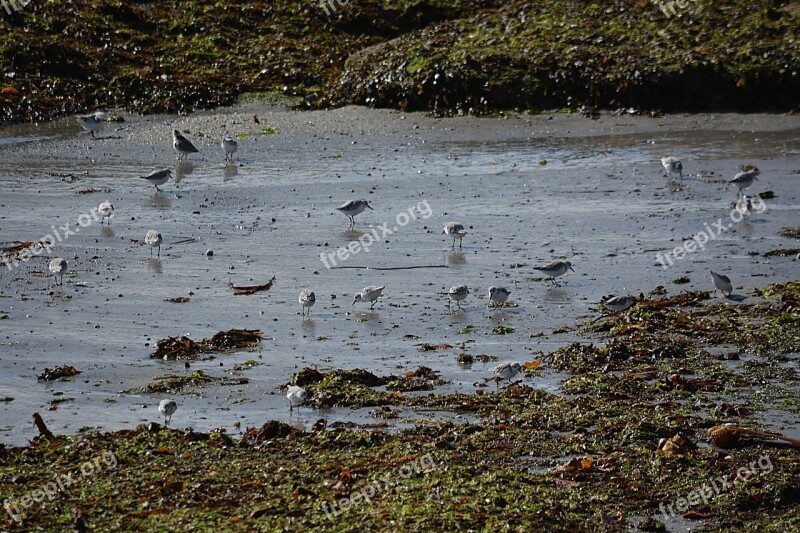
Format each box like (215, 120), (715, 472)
(72, 112), (760, 425)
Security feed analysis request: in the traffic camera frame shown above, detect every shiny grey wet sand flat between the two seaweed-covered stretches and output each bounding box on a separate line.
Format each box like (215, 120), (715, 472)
(0, 104), (800, 445)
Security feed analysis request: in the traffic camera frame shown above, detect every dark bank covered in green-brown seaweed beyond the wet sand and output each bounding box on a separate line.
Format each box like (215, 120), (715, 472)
(0, 0), (800, 123)
